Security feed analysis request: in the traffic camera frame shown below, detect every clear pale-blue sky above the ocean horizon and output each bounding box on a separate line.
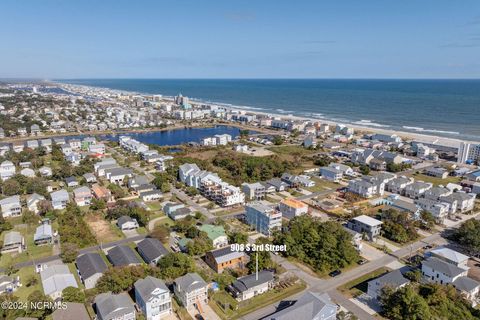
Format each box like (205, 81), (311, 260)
(0, 0), (480, 79)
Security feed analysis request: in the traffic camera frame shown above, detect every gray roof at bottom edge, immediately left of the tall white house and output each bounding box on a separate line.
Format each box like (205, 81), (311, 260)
(95, 292), (135, 319)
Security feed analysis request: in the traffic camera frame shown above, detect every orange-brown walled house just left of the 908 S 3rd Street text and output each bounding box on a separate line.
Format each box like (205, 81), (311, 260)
(205, 246), (248, 273)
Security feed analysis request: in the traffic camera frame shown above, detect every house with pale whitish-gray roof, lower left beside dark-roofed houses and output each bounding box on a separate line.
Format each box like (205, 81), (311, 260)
(40, 264), (78, 300)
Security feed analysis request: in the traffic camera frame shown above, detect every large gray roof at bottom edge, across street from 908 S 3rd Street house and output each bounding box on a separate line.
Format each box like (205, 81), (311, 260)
(265, 291), (337, 320)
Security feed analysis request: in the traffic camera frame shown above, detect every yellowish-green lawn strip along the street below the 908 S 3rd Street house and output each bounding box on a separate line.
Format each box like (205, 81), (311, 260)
(209, 282), (307, 320)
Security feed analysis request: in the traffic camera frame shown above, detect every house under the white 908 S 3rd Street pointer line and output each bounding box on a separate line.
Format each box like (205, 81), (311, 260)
(228, 270), (274, 301)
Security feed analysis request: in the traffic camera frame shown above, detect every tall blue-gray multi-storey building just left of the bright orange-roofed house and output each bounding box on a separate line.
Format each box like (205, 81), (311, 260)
(245, 201), (282, 236)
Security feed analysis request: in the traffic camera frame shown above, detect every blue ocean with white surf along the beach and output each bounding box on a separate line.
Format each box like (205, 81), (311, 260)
(57, 79), (480, 140)
